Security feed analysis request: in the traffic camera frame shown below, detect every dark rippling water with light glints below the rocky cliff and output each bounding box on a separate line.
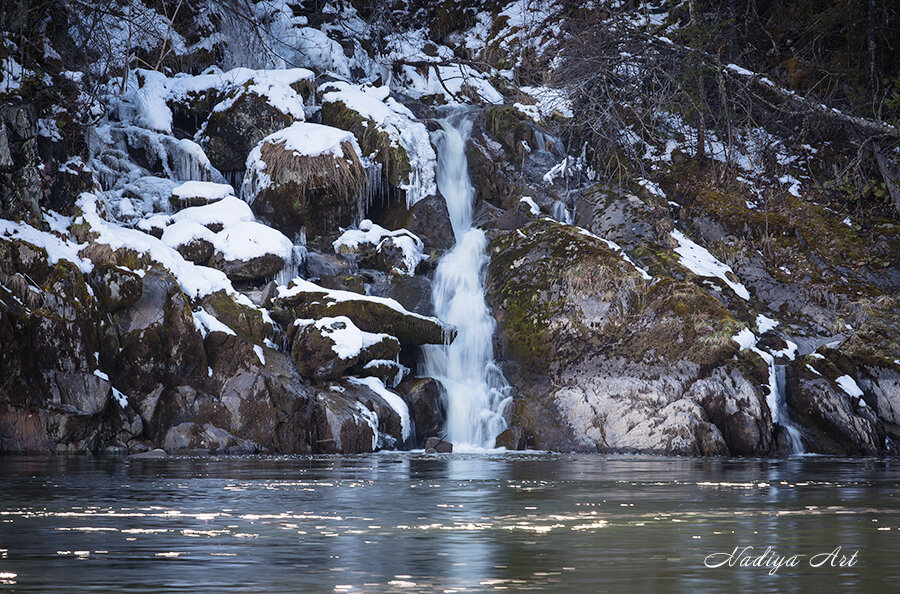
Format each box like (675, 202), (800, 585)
(0, 453), (900, 592)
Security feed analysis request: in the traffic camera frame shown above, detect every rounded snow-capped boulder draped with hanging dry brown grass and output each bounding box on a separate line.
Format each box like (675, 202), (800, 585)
(245, 123), (367, 238)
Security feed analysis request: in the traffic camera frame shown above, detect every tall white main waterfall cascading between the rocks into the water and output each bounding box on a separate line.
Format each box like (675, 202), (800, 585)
(423, 111), (510, 449)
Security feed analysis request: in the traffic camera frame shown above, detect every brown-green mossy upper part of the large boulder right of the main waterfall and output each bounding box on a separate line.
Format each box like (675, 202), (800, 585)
(488, 220), (743, 373)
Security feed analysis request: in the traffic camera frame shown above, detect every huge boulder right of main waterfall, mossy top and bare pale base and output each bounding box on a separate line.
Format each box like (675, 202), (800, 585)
(487, 220), (773, 455)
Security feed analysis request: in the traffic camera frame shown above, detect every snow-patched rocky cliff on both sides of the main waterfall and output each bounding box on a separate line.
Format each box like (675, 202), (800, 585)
(0, 0), (900, 456)
